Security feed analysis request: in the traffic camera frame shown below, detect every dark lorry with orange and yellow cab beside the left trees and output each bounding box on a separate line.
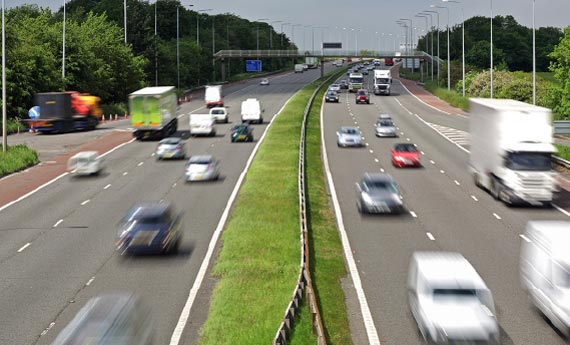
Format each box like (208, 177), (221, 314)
(23, 91), (103, 133)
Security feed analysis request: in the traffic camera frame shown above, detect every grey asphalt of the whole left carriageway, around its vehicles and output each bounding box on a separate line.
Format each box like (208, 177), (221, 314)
(0, 66), (330, 345)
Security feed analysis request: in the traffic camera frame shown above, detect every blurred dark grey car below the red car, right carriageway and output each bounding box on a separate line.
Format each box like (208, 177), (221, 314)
(356, 173), (405, 213)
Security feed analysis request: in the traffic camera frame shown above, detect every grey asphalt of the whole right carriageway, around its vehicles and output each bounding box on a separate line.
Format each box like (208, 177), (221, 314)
(322, 68), (568, 345)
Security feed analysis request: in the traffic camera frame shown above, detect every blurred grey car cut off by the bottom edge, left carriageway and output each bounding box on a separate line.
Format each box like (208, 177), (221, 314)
(52, 293), (154, 345)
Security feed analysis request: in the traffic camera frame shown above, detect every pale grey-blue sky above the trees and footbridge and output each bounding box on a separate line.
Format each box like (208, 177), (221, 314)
(5, 0), (570, 50)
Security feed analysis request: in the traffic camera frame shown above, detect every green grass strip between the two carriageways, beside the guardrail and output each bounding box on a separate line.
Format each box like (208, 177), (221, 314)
(201, 67), (348, 344)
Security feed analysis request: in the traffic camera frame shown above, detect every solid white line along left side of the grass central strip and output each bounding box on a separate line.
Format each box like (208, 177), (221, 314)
(169, 94), (294, 345)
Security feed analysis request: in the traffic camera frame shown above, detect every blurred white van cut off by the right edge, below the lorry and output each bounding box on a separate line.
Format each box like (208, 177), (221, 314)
(520, 221), (570, 337)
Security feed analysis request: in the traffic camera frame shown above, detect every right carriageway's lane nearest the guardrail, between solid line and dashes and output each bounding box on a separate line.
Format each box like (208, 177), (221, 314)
(323, 95), (436, 344)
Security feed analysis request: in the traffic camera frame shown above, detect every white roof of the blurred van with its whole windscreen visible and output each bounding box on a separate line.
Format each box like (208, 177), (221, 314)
(412, 251), (487, 289)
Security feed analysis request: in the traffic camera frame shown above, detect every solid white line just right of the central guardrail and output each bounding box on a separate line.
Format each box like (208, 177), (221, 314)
(318, 96), (380, 345)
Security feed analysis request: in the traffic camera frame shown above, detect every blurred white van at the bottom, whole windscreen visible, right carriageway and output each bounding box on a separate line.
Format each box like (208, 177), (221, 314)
(408, 252), (499, 344)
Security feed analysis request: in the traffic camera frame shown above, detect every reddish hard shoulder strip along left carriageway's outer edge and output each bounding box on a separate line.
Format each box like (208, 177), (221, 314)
(0, 131), (133, 210)
